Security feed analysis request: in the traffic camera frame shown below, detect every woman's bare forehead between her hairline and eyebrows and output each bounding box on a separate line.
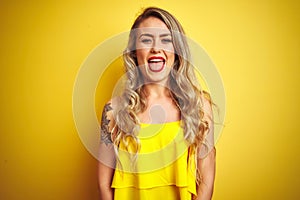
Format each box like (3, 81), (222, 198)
(137, 17), (171, 35)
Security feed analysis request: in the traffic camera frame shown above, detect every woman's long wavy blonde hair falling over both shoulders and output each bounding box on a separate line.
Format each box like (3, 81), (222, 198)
(113, 7), (210, 181)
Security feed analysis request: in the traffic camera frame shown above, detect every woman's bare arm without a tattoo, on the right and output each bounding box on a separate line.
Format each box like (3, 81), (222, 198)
(197, 94), (216, 200)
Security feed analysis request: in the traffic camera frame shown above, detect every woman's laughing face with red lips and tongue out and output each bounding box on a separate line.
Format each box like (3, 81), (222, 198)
(136, 17), (175, 84)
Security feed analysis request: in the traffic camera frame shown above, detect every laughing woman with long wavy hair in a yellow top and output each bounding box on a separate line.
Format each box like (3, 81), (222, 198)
(98, 7), (215, 200)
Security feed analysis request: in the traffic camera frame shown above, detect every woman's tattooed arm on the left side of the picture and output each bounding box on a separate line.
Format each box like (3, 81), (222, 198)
(98, 103), (115, 200)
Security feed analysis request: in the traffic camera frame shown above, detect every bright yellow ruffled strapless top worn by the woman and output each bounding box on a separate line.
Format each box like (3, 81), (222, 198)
(112, 121), (196, 200)
